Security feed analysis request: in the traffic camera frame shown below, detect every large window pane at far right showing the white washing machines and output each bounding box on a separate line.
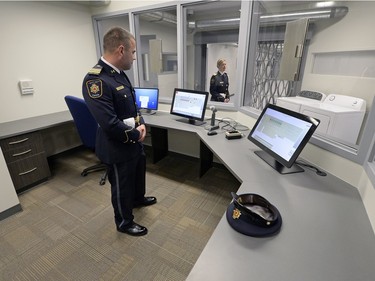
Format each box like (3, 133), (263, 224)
(243, 1), (375, 160)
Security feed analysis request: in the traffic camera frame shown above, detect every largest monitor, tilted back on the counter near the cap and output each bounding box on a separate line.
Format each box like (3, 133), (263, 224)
(248, 104), (320, 174)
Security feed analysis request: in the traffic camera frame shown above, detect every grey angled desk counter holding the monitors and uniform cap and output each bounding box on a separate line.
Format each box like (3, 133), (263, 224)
(0, 112), (375, 281)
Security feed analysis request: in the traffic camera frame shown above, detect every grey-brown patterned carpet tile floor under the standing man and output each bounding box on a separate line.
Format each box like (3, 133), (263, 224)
(0, 149), (240, 281)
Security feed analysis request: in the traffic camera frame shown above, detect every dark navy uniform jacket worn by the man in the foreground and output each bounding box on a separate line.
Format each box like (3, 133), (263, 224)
(82, 60), (144, 164)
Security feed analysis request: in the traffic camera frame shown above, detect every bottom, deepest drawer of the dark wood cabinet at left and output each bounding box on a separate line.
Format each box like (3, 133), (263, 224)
(8, 152), (51, 190)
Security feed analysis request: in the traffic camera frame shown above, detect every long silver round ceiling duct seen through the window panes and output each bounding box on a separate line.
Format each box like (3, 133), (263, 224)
(188, 7), (348, 30)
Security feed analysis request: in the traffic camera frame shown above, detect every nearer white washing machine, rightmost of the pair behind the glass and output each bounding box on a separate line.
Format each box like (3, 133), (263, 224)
(299, 94), (366, 144)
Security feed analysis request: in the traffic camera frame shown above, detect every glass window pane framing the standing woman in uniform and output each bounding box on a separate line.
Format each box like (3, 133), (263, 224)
(183, 1), (241, 104)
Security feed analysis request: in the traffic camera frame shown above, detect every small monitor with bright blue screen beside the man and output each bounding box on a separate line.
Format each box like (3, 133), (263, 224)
(134, 87), (159, 114)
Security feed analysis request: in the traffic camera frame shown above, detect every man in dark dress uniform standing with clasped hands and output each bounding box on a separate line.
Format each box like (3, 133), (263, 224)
(82, 27), (156, 236)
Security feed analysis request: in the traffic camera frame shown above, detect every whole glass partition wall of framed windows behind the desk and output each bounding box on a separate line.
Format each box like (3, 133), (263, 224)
(93, 1), (375, 163)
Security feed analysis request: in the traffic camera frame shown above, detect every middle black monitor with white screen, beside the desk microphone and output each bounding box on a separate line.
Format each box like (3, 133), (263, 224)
(170, 88), (208, 126)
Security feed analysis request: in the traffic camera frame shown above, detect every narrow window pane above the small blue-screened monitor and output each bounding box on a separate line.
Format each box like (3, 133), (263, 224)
(134, 7), (178, 100)
